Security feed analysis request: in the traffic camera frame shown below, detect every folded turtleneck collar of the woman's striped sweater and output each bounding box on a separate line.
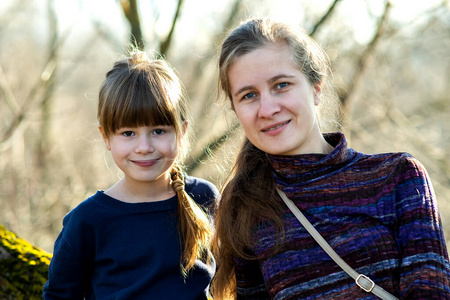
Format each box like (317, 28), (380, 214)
(267, 132), (357, 188)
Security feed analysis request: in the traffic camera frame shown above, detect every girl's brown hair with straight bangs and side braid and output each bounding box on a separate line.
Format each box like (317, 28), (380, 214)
(97, 50), (212, 276)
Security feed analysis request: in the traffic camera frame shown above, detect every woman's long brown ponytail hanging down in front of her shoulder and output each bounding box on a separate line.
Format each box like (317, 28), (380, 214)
(212, 139), (283, 299)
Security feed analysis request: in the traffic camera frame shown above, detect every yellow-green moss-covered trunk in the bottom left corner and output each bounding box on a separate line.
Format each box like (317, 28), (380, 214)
(0, 225), (52, 300)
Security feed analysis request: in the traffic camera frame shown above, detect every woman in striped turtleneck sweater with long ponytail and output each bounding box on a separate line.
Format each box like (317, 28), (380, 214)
(213, 19), (450, 300)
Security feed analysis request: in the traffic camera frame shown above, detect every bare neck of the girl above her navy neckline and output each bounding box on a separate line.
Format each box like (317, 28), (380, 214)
(105, 176), (175, 203)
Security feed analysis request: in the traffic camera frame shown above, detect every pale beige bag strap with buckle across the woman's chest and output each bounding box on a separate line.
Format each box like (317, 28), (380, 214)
(275, 187), (398, 300)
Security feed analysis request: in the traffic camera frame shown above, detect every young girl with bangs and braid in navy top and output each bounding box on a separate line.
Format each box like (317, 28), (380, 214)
(43, 51), (218, 299)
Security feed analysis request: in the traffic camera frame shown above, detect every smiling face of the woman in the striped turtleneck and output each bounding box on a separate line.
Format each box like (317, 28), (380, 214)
(228, 44), (323, 155)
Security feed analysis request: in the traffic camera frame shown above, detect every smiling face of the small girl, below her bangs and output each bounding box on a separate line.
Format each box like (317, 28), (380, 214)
(100, 126), (179, 187)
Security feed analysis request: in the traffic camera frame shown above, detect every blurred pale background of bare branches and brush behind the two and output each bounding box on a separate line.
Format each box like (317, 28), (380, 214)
(0, 0), (450, 252)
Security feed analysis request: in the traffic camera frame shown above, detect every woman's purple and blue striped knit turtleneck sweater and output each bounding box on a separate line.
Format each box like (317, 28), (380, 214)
(234, 133), (450, 300)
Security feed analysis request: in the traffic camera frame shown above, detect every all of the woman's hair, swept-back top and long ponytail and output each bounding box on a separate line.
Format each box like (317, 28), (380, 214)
(212, 18), (336, 299)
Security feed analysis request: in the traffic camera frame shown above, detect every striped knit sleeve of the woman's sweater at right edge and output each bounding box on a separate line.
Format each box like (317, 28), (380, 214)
(395, 155), (450, 299)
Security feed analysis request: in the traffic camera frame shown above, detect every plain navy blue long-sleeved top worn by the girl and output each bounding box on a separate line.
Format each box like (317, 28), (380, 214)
(43, 176), (218, 299)
